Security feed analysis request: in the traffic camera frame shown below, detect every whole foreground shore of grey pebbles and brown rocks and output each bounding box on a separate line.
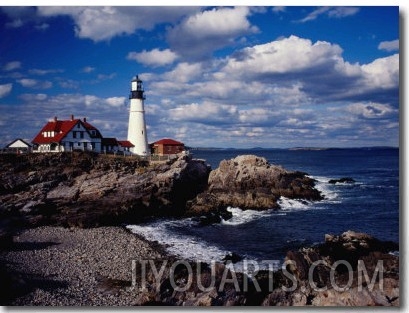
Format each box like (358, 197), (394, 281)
(0, 226), (399, 306)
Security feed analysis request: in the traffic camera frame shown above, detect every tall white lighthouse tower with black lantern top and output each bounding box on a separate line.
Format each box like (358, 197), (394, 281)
(128, 75), (150, 156)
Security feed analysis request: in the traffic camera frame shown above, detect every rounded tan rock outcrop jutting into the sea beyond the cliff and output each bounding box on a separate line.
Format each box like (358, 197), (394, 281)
(190, 155), (323, 214)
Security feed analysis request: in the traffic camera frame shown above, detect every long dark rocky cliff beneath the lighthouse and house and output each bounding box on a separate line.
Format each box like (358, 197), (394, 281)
(0, 152), (210, 229)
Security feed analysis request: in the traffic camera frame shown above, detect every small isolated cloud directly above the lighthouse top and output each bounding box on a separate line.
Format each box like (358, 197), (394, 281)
(127, 48), (178, 67)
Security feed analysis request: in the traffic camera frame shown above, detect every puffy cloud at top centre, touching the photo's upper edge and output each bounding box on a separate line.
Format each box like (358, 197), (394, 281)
(167, 7), (258, 59)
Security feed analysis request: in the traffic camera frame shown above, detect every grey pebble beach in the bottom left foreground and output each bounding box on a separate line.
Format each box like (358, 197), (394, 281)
(0, 226), (164, 306)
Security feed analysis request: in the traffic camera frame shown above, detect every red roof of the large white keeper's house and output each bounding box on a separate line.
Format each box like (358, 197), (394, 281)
(32, 118), (102, 144)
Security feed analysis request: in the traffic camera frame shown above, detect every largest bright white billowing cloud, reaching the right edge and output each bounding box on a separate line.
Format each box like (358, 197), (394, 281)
(216, 36), (399, 102)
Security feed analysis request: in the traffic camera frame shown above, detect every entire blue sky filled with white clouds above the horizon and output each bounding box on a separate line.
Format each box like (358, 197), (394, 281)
(0, 6), (399, 148)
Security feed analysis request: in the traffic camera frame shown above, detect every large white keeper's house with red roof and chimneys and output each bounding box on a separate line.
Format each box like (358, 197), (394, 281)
(32, 115), (102, 152)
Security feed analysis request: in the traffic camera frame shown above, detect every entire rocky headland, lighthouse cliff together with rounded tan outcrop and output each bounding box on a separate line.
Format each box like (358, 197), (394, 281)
(0, 152), (322, 234)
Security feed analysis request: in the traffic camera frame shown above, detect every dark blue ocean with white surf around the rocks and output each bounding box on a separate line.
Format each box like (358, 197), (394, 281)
(128, 148), (399, 262)
